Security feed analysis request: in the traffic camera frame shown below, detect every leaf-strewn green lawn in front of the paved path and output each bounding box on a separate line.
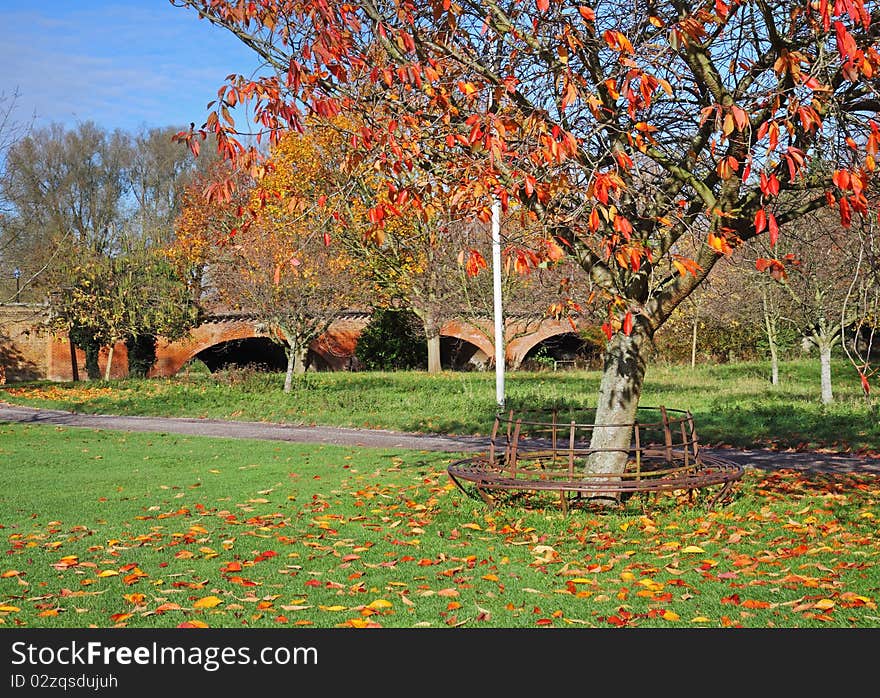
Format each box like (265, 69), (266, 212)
(0, 422), (880, 628)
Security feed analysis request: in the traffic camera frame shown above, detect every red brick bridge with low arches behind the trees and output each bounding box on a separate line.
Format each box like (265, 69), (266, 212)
(0, 304), (595, 382)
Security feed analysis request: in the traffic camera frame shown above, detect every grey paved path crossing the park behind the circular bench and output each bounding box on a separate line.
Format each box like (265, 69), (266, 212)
(0, 403), (880, 474)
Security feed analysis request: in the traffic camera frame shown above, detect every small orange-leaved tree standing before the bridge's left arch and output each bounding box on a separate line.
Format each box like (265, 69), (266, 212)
(199, 134), (365, 392)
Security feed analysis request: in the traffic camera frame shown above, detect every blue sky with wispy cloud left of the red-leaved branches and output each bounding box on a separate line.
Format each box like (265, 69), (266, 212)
(0, 0), (258, 131)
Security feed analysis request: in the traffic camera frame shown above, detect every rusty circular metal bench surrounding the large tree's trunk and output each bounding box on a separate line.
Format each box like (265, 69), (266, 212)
(447, 407), (744, 513)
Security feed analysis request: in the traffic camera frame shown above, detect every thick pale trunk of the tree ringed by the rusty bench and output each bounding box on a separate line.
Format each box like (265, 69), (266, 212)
(586, 327), (648, 501)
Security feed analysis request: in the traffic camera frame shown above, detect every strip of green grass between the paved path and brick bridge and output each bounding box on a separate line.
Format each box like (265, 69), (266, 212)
(0, 360), (880, 452)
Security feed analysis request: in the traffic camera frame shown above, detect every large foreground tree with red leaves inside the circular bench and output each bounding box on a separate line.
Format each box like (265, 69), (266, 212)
(172, 0), (880, 486)
